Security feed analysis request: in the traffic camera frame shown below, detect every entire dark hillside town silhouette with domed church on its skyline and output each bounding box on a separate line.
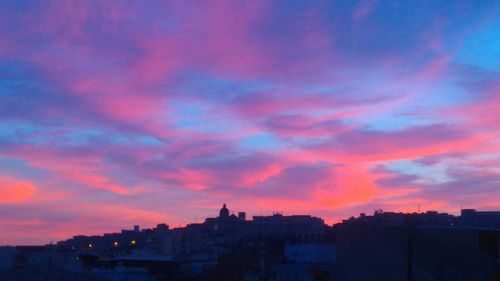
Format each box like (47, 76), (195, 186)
(0, 204), (500, 281)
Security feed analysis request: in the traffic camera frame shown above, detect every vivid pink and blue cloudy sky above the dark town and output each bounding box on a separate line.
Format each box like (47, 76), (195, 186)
(0, 0), (500, 245)
